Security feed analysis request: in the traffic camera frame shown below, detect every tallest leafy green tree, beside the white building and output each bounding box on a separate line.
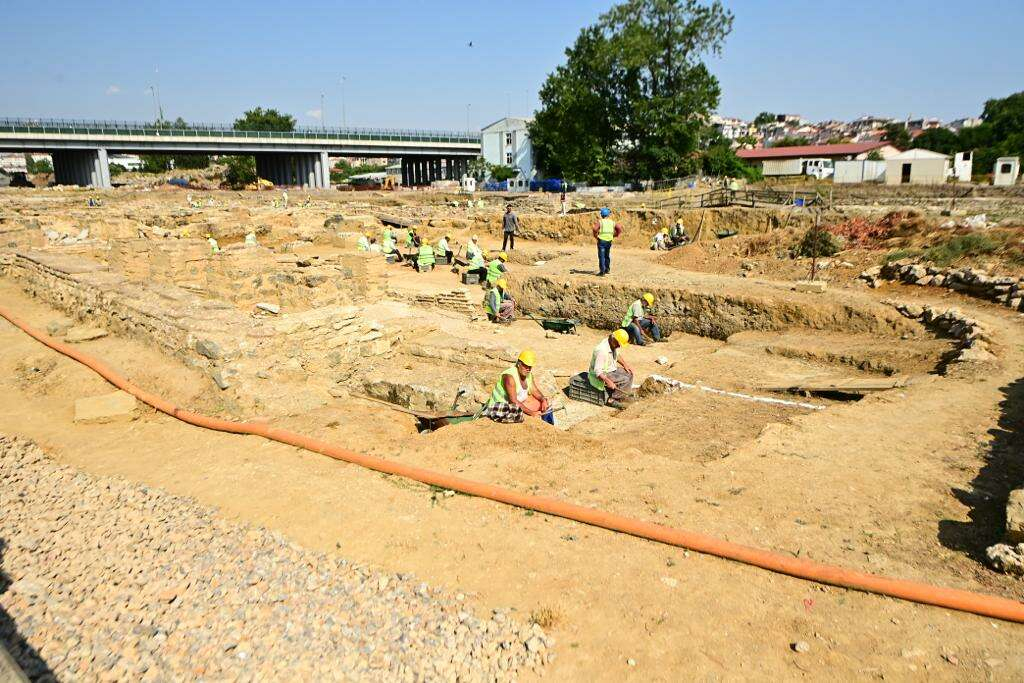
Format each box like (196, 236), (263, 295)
(530, 0), (732, 182)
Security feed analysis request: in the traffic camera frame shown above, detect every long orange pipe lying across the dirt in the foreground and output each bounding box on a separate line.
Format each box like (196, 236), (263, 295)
(0, 306), (1024, 623)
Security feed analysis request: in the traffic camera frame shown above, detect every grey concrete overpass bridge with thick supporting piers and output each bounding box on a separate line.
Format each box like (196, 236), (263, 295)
(0, 119), (480, 188)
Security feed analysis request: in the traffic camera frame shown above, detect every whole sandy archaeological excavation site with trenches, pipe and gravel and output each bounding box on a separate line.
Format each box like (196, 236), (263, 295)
(0, 185), (1024, 680)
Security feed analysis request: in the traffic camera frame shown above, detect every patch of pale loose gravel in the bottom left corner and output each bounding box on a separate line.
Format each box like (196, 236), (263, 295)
(0, 435), (554, 681)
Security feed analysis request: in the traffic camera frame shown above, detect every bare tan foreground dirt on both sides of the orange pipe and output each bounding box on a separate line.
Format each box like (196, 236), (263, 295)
(0, 280), (1024, 680)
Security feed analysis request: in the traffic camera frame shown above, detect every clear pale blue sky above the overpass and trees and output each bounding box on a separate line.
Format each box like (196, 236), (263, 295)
(0, 0), (1024, 129)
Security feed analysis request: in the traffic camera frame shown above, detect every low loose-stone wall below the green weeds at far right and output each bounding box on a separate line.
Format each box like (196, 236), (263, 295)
(860, 260), (1024, 310)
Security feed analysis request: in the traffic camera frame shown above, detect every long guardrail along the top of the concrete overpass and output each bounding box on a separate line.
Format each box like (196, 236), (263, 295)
(0, 118), (480, 144)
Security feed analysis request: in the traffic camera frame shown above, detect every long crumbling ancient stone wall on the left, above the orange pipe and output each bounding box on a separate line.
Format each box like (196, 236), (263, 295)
(0, 251), (400, 414)
